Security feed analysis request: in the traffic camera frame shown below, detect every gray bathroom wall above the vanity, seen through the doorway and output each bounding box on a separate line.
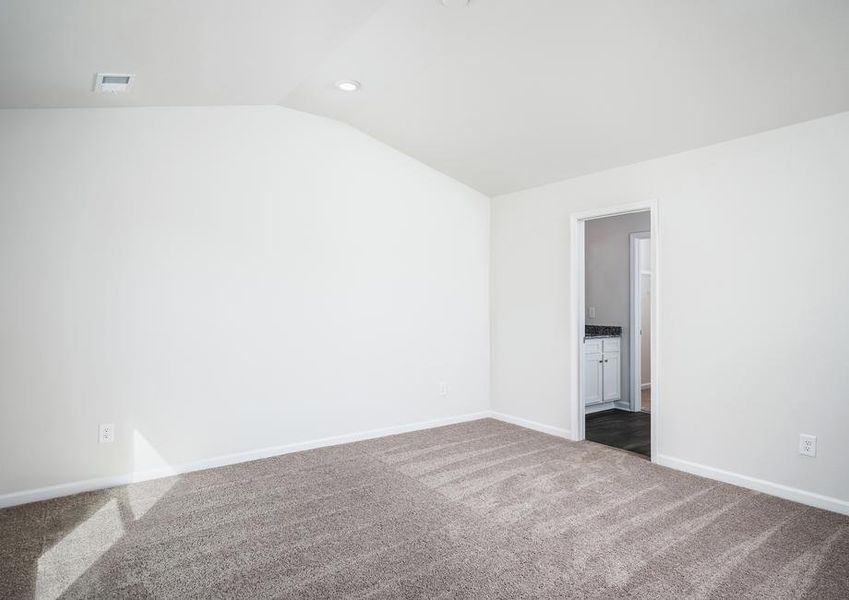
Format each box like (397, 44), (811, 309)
(584, 212), (651, 404)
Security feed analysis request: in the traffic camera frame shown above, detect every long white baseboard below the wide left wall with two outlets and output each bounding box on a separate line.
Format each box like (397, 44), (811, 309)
(0, 410), (492, 508)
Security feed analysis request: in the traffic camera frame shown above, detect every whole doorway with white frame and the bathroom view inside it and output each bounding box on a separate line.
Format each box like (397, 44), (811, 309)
(571, 202), (659, 459)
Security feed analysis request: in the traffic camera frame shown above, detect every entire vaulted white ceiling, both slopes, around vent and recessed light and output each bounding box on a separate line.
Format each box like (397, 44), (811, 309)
(0, 0), (849, 195)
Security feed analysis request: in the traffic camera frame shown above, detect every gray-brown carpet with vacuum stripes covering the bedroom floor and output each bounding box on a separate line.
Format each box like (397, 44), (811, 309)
(0, 419), (849, 600)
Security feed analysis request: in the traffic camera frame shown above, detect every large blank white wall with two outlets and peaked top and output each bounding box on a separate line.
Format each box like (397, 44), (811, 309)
(0, 107), (489, 494)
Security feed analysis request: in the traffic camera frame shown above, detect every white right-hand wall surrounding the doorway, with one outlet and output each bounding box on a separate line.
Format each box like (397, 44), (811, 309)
(491, 113), (849, 507)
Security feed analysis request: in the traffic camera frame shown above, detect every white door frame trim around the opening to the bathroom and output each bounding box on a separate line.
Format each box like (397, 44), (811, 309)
(569, 200), (661, 462)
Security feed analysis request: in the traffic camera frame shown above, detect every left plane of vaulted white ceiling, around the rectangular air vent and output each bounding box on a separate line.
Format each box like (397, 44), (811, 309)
(0, 0), (382, 108)
